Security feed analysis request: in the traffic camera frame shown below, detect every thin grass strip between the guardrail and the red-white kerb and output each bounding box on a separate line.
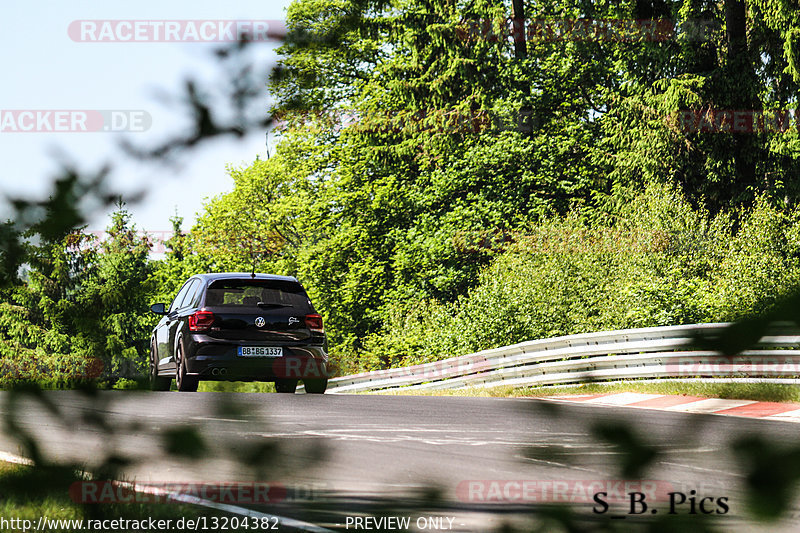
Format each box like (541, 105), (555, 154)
(370, 380), (800, 403)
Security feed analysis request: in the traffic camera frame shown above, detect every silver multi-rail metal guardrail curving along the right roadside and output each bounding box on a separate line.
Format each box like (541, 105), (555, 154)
(328, 323), (800, 393)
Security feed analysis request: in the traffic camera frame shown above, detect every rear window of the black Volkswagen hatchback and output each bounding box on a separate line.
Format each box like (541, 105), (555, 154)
(206, 279), (312, 313)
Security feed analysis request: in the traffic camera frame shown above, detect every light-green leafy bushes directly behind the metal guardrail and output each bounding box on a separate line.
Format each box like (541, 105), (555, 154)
(359, 186), (800, 369)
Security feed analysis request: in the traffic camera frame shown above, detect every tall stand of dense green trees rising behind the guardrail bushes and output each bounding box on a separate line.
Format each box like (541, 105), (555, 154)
(190, 0), (797, 374)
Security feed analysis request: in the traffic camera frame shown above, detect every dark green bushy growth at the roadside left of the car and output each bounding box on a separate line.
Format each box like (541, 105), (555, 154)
(0, 204), (153, 386)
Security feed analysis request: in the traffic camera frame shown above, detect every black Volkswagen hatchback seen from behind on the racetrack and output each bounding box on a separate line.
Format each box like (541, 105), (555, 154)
(150, 273), (328, 394)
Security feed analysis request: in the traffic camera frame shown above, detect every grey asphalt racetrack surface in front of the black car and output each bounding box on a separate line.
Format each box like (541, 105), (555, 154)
(0, 391), (800, 531)
